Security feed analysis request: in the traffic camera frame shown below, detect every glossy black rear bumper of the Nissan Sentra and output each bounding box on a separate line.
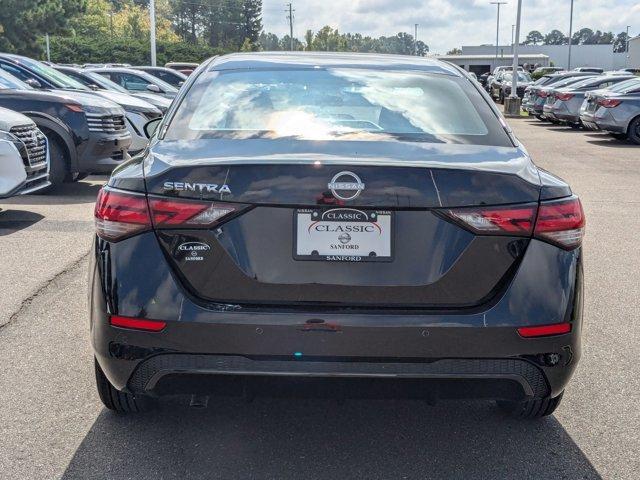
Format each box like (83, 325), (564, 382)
(90, 233), (582, 398)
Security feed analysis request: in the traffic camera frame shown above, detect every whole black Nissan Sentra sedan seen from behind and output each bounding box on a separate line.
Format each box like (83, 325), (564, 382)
(90, 53), (585, 418)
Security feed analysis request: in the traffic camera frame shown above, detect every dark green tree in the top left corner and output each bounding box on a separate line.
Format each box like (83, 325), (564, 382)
(0, 0), (86, 57)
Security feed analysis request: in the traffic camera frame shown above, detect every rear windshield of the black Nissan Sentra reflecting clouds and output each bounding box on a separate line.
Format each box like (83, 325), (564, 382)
(165, 68), (512, 146)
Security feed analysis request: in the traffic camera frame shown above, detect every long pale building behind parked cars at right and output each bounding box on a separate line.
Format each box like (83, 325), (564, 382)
(437, 43), (640, 75)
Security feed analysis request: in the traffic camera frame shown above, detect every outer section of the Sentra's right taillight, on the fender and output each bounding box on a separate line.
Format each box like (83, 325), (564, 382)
(534, 197), (585, 249)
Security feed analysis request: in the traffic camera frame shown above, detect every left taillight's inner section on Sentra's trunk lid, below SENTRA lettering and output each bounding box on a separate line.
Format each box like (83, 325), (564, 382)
(149, 197), (238, 228)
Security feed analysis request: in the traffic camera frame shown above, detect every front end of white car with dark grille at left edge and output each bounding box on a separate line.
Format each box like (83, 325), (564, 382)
(0, 108), (50, 198)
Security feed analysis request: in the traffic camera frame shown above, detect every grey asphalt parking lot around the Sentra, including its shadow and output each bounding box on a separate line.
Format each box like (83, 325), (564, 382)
(0, 118), (640, 480)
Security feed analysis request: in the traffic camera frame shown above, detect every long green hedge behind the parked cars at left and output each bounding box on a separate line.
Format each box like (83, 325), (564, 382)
(51, 36), (227, 65)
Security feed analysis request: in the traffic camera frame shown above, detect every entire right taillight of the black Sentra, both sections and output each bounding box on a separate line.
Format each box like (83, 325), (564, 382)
(438, 197), (585, 250)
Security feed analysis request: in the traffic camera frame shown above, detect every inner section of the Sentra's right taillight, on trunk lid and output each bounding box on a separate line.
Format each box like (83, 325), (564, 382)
(443, 204), (537, 236)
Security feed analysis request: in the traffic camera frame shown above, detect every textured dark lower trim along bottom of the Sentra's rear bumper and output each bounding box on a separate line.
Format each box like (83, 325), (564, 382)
(127, 354), (551, 398)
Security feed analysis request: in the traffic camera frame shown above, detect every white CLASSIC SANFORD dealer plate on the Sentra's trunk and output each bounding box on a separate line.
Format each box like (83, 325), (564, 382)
(293, 208), (393, 262)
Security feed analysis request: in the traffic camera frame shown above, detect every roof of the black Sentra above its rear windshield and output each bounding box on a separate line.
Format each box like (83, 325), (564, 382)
(209, 52), (462, 77)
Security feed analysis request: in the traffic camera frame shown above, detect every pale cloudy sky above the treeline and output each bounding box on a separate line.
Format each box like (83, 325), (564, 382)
(262, 0), (640, 53)
